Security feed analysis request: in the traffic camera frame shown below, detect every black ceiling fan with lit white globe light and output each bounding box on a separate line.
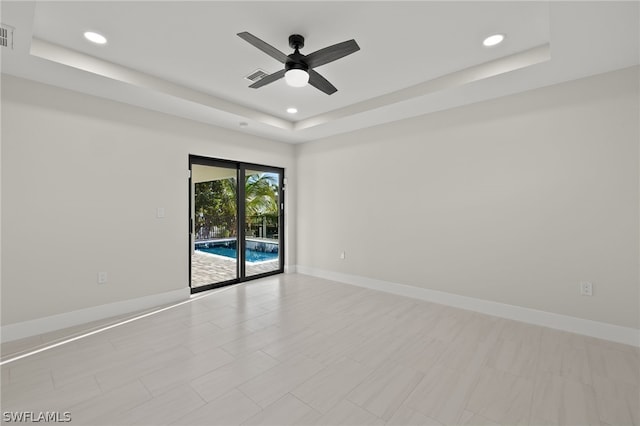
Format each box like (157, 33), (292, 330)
(238, 31), (360, 95)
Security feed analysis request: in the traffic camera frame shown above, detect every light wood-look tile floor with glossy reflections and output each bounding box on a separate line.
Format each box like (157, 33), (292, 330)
(1, 274), (640, 426)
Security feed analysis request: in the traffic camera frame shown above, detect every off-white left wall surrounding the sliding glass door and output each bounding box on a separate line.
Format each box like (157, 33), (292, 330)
(2, 75), (296, 326)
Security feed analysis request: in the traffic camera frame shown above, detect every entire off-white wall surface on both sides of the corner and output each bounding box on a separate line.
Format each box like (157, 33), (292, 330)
(1, 68), (640, 336)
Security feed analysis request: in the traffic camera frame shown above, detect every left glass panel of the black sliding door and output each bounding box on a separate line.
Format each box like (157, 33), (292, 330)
(191, 164), (238, 288)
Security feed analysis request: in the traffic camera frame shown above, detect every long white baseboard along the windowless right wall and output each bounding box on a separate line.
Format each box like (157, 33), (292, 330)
(296, 265), (640, 347)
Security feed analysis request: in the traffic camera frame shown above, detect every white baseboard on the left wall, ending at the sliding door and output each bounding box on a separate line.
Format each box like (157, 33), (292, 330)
(0, 288), (191, 343)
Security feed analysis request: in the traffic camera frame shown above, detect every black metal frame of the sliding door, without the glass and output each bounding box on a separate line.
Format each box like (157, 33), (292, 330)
(187, 154), (285, 294)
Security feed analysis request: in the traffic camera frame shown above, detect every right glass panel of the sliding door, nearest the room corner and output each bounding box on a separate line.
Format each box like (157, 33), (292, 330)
(243, 168), (282, 277)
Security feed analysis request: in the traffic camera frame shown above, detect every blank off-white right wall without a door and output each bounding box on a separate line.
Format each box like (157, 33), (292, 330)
(297, 67), (640, 329)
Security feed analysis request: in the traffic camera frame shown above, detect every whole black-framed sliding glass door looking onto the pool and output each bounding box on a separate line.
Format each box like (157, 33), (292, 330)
(189, 156), (284, 293)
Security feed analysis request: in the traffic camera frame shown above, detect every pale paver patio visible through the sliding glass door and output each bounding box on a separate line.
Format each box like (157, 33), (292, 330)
(191, 250), (279, 287)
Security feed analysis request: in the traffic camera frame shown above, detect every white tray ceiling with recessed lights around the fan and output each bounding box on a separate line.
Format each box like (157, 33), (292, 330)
(1, 1), (640, 142)
